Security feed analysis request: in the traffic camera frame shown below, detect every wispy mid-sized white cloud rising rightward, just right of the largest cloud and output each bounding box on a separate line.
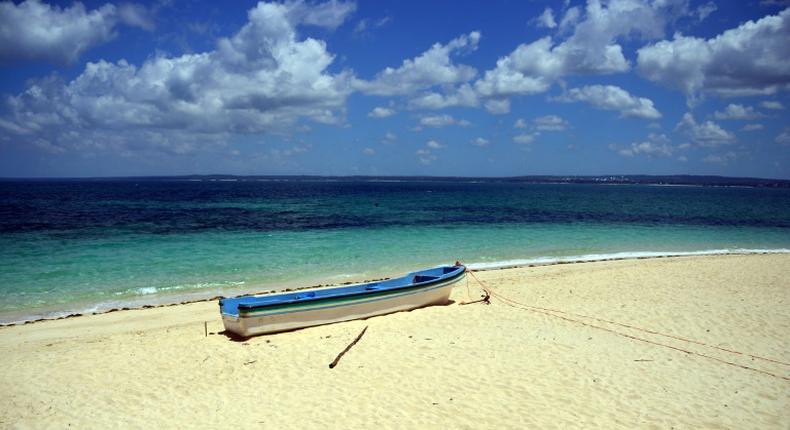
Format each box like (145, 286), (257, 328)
(355, 31), (480, 96)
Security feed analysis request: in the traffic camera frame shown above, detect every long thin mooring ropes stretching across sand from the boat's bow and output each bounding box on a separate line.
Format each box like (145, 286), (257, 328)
(467, 270), (790, 381)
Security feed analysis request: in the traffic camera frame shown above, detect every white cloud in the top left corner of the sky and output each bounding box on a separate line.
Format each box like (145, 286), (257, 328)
(0, 0), (117, 63)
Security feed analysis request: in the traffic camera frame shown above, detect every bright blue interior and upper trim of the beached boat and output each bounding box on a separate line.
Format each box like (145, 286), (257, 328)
(219, 266), (466, 317)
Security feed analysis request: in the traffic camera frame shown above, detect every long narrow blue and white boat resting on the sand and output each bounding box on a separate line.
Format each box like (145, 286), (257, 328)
(219, 264), (466, 338)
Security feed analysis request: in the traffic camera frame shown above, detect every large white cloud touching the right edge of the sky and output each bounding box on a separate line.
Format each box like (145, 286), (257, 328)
(637, 8), (790, 103)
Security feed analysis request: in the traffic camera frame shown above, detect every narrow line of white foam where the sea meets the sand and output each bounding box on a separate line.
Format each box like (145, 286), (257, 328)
(0, 248), (790, 329)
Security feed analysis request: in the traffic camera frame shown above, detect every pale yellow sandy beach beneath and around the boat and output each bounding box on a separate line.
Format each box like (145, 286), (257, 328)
(0, 255), (790, 429)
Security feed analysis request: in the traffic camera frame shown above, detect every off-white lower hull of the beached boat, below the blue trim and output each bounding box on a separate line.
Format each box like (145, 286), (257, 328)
(222, 274), (466, 337)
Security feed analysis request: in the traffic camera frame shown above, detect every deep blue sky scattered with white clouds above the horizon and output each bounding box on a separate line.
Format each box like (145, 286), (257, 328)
(0, 0), (790, 179)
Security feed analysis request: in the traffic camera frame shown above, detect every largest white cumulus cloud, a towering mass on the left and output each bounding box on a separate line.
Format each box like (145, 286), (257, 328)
(4, 3), (352, 153)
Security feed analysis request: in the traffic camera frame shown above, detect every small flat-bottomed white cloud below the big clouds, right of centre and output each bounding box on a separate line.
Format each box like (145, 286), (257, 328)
(556, 85), (661, 119)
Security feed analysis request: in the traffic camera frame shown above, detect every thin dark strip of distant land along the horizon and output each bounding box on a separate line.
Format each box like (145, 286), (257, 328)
(0, 175), (790, 188)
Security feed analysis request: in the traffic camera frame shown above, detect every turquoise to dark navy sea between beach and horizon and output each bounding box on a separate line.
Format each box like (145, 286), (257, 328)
(0, 178), (790, 324)
